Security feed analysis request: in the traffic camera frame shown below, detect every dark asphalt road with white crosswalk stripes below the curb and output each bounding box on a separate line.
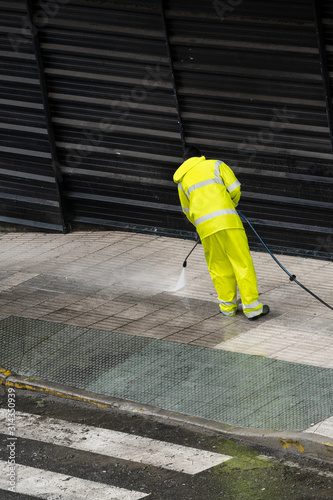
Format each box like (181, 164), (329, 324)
(0, 386), (333, 500)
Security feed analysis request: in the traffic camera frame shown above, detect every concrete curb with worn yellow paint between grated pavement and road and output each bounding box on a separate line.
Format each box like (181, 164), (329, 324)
(0, 368), (333, 463)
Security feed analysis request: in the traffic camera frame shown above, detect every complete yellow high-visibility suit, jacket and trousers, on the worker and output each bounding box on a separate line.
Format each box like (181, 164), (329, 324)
(173, 156), (263, 318)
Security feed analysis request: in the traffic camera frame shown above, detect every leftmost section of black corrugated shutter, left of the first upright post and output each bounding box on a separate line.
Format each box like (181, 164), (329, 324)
(0, 1), (64, 231)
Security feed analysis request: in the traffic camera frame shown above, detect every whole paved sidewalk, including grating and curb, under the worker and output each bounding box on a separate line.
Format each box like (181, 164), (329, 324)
(0, 231), (333, 460)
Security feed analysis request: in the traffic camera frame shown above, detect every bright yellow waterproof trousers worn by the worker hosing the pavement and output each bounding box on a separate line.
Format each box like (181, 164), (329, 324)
(202, 229), (263, 318)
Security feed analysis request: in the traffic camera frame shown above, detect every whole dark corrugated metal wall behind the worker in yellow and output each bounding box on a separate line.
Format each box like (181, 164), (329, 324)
(0, 0), (333, 258)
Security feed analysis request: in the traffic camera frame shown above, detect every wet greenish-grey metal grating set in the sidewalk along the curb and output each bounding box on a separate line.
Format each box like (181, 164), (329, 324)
(0, 317), (333, 431)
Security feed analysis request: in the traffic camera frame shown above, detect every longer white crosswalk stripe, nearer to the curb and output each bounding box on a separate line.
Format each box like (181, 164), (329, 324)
(0, 408), (232, 474)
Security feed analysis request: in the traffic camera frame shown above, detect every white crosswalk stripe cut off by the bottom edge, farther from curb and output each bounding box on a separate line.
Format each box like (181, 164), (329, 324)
(0, 460), (149, 500)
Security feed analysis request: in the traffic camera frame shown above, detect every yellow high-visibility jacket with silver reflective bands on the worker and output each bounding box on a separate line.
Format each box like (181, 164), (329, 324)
(173, 156), (243, 239)
